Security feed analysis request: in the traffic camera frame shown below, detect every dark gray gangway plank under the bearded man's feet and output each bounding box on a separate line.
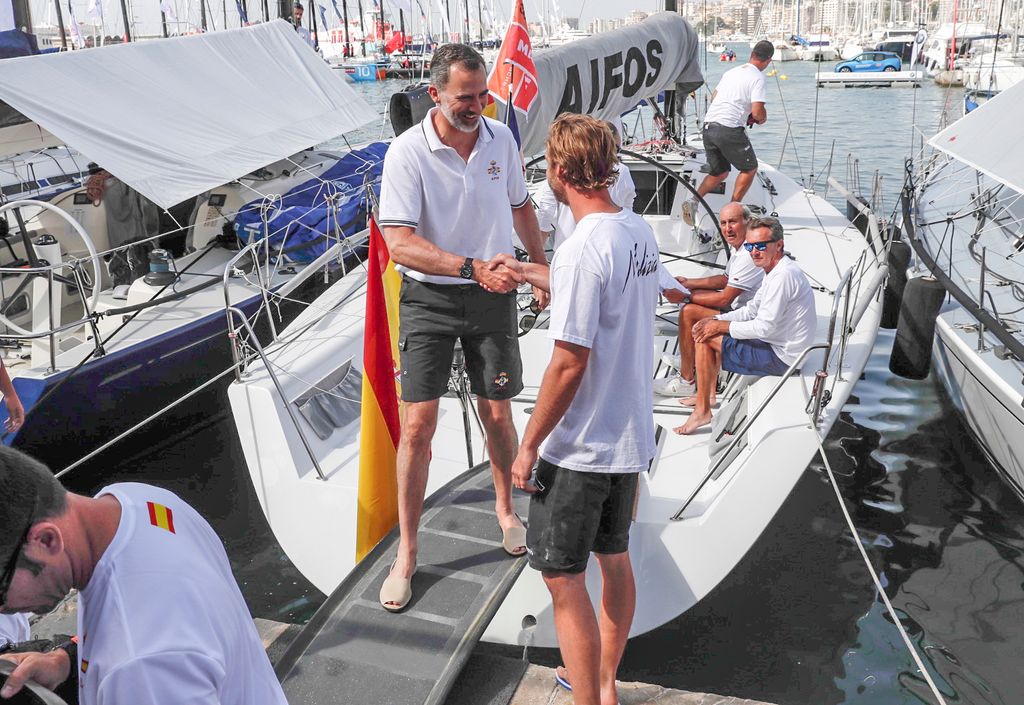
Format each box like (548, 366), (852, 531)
(275, 463), (529, 705)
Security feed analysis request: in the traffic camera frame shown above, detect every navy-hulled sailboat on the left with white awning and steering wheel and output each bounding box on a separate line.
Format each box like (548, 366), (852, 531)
(0, 20), (384, 469)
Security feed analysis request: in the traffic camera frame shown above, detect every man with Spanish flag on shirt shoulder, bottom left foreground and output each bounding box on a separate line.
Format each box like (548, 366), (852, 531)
(0, 446), (287, 705)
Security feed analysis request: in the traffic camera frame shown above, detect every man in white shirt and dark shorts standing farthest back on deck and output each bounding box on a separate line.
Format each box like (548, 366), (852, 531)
(683, 39), (775, 224)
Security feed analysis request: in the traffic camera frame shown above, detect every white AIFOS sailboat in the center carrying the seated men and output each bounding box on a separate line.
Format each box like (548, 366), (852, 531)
(228, 12), (886, 655)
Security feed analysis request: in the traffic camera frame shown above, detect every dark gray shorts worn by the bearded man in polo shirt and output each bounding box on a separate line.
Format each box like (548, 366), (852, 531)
(398, 277), (522, 402)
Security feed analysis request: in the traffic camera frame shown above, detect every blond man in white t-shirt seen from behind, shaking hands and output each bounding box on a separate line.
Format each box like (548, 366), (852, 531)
(501, 115), (659, 705)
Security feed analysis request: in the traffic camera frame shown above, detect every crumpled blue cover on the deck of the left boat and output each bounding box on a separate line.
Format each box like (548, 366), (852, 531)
(234, 142), (388, 261)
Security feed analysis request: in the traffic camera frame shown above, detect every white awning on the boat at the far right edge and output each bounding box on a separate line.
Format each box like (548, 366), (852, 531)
(928, 77), (1024, 194)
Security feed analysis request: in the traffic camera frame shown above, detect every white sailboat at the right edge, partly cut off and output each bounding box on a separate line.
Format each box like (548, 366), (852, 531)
(893, 83), (1024, 497)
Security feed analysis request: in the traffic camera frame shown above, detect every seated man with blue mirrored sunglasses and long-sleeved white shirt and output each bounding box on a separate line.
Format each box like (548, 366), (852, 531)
(675, 217), (817, 436)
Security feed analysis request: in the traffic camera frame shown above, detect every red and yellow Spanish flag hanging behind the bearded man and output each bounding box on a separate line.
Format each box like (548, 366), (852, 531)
(355, 218), (401, 562)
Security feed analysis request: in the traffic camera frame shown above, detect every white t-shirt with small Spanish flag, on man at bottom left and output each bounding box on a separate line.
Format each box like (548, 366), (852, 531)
(78, 483), (288, 705)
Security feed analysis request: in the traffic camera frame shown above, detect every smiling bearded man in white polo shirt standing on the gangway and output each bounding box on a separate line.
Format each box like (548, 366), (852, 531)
(379, 44), (547, 612)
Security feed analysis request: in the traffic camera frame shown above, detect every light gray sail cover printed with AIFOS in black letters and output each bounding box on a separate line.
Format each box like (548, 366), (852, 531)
(520, 12), (703, 155)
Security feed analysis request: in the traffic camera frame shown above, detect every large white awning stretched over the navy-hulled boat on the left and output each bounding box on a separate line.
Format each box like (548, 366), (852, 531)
(0, 19), (378, 208)
